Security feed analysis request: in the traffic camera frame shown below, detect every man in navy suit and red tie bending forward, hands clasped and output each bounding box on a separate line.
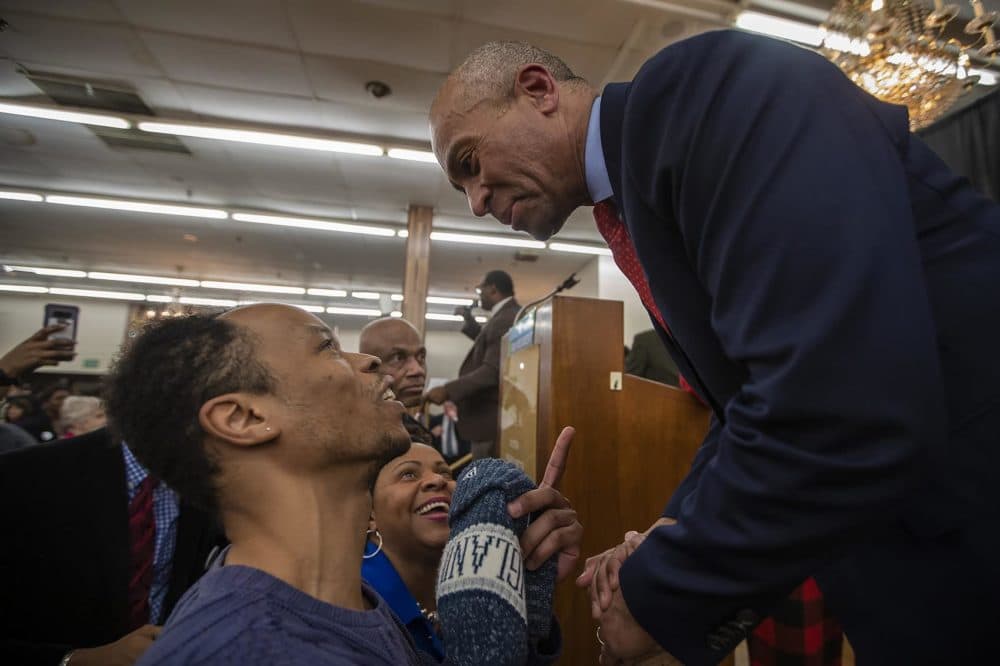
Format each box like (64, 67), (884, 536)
(431, 31), (1000, 664)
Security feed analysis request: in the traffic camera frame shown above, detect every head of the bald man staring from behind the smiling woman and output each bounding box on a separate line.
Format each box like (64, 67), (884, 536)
(358, 317), (427, 407)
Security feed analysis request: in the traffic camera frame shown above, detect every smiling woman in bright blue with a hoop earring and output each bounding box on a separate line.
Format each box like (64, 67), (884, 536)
(361, 442), (455, 661)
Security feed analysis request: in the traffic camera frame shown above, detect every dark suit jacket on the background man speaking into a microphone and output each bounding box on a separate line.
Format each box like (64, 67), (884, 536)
(445, 297), (521, 458)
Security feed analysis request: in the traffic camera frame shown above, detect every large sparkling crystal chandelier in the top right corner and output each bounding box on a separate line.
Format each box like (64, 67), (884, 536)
(822, 0), (1000, 130)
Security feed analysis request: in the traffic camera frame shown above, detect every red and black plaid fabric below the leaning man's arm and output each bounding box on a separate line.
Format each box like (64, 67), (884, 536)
(747, 578), (844, 666)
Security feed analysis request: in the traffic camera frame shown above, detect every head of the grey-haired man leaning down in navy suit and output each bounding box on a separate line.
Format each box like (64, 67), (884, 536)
(430, 42), (597, 240)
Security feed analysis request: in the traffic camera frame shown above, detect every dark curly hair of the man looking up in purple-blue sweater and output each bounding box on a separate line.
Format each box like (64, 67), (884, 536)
(105, 315), (275, 513)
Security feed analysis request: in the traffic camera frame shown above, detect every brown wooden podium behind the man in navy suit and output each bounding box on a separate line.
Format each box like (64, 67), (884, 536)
(499, 296), (709, 664)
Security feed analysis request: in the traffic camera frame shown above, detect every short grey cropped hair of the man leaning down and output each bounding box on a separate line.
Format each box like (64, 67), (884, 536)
(449, 42), (584, 105)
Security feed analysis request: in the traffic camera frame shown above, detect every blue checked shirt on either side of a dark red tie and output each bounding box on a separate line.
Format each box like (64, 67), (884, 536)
(122, 444), (181, 624)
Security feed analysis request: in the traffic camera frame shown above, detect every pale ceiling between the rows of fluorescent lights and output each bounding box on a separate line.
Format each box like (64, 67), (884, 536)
(0, 0), (992, 308)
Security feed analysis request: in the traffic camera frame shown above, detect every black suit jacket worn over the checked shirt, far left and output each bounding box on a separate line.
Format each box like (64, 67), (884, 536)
(0, 428), (221, 666)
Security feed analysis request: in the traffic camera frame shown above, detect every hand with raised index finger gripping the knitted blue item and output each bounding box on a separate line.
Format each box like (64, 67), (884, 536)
(507, 426), (583, 580)
